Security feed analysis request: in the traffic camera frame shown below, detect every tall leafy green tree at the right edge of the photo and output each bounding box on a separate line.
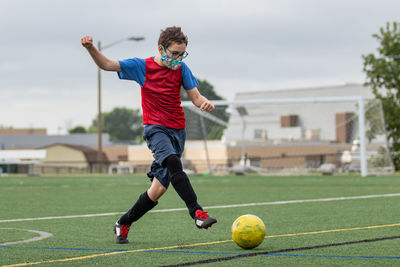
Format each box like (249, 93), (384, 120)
(363, 22), (400, 170)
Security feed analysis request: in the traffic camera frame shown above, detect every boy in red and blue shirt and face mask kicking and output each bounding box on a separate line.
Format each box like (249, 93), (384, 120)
(81, 27), (217, 244)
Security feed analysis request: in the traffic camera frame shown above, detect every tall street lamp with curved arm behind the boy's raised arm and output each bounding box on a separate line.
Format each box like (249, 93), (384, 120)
(97, 36), (144, 173)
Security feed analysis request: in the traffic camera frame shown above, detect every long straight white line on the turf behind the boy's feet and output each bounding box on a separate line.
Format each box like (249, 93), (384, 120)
(0, 193), (400, 223)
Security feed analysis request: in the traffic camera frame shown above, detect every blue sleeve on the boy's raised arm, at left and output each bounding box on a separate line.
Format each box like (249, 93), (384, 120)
(118, 57), (146, 86)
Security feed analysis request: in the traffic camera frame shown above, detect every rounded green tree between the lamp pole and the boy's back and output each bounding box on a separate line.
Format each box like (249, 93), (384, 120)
(89, 107), (143, 141)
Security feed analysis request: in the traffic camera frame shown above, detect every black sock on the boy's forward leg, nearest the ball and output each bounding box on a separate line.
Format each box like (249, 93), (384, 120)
(171, 171), (203, 219)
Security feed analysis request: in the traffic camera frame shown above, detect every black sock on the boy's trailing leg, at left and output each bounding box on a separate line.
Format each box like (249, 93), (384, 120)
(118, 191), (158, 225)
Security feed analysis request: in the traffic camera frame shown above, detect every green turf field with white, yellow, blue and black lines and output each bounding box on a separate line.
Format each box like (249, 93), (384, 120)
(0, 175), (400, 266)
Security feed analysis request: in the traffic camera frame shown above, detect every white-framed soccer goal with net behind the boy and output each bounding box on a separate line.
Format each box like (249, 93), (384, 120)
(182, 96), (394, 176)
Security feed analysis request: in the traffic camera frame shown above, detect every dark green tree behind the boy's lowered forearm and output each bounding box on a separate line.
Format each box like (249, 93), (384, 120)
(181, 79), (229, 140)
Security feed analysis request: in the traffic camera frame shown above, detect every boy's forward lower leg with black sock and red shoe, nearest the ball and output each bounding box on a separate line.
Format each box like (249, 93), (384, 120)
(163, 155), (217, 228)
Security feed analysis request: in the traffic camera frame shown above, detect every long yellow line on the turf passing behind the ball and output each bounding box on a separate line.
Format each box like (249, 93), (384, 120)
(1, 223), (400, 267)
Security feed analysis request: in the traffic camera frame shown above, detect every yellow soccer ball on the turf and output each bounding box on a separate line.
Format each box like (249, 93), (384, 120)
(232, 214), (265, 249)
